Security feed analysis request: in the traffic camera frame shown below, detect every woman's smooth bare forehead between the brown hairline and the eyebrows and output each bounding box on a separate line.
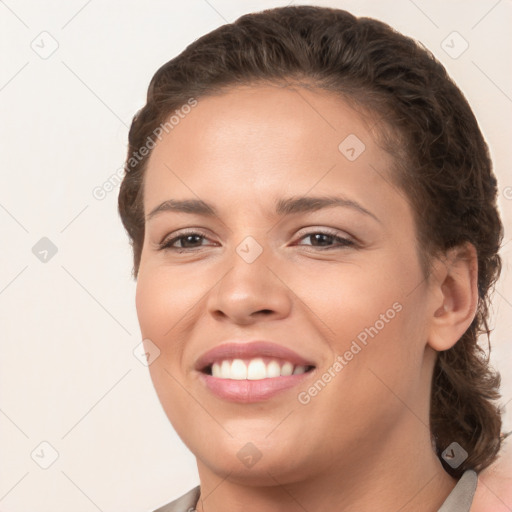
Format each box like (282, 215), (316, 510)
(145, 86), (398, 211)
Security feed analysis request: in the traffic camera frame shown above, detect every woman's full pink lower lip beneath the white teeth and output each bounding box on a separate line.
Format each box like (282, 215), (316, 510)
(200, 370), (314, 403)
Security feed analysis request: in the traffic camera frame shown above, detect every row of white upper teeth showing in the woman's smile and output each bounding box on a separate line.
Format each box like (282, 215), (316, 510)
(212, 357), (306, 380)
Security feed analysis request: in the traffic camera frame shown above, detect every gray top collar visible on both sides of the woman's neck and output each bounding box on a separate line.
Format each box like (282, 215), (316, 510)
(154, 469), (478, 512)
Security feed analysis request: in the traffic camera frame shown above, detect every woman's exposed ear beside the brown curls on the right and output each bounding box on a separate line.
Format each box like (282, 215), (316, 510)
(428, 242), (478, 351)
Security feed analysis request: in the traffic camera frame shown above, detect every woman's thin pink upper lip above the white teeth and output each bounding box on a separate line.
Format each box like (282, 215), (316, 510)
(195, 340), (315, 371)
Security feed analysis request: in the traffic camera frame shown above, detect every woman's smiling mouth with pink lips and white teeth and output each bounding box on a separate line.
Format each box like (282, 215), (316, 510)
(195, 341), (316, 403)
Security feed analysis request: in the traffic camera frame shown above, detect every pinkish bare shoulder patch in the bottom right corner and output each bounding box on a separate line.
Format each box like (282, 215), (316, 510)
(470, 446), (512, 512)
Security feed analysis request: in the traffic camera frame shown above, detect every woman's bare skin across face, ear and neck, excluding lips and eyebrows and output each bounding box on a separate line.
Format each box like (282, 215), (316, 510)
(136, 85), (477, 512)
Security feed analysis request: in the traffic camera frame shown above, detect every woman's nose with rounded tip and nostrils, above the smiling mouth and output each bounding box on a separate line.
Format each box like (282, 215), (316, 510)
(208, 243), (293, 325)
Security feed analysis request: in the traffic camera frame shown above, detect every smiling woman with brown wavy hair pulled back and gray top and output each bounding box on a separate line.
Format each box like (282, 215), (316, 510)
(119, 6), (503, 512)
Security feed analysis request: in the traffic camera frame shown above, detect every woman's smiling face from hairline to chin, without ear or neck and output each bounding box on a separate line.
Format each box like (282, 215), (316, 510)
(136, 86), (440, 483)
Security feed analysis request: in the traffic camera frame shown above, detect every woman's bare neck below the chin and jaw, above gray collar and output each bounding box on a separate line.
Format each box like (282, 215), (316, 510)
(196, 414), (456, 512)
